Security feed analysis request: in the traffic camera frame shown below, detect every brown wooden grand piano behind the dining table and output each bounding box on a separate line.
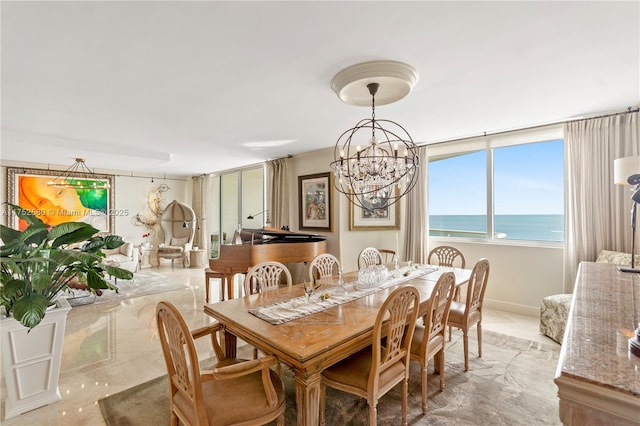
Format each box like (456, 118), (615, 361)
(209, 228), (327, 299)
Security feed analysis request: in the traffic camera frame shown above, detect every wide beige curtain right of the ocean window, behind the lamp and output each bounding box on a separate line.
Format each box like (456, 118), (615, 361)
(564, 112), (640, 292)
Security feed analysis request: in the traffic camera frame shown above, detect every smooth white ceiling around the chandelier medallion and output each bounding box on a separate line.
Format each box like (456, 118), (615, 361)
(0, 1), (640, 175)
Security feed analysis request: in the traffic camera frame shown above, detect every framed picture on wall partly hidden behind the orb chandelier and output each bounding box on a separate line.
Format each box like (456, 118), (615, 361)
(349, 190), (400, 231)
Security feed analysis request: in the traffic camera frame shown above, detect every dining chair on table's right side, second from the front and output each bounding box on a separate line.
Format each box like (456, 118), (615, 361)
(411, 272), (456, 414)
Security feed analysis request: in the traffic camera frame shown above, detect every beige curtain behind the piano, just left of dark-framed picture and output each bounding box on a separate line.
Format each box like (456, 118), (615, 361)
(267, 158), (291, 228)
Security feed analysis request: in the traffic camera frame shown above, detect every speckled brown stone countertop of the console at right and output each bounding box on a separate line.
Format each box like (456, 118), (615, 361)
(557, 262), (640, 397)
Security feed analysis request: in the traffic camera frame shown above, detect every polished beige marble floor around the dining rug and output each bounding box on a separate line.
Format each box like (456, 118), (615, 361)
(0, 264), (557, 426)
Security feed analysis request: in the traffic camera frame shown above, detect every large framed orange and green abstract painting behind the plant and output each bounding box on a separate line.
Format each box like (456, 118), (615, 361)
(6, 167), (115, 233)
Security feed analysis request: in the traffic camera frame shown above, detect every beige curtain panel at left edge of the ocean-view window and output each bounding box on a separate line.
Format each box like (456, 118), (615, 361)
(398, 146), (429, 263)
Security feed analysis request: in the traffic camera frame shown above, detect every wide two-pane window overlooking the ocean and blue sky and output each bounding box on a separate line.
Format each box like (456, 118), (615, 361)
(428, 130), (564, 242)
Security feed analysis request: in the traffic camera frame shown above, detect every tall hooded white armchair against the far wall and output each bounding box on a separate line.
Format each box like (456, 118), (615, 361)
(157, 200), (196, 267)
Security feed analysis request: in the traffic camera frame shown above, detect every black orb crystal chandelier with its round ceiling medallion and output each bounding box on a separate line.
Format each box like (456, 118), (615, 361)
(330, 61), (419, 210)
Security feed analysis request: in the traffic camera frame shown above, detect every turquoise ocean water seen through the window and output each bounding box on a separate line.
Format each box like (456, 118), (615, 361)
(429, 214), (564, 241)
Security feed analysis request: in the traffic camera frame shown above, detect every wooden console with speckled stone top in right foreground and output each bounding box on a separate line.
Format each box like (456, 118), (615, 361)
(555, 262), (640, 425)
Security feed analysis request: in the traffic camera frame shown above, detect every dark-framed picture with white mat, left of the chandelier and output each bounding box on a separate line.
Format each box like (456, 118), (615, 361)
(298, 173), (333, 231)
